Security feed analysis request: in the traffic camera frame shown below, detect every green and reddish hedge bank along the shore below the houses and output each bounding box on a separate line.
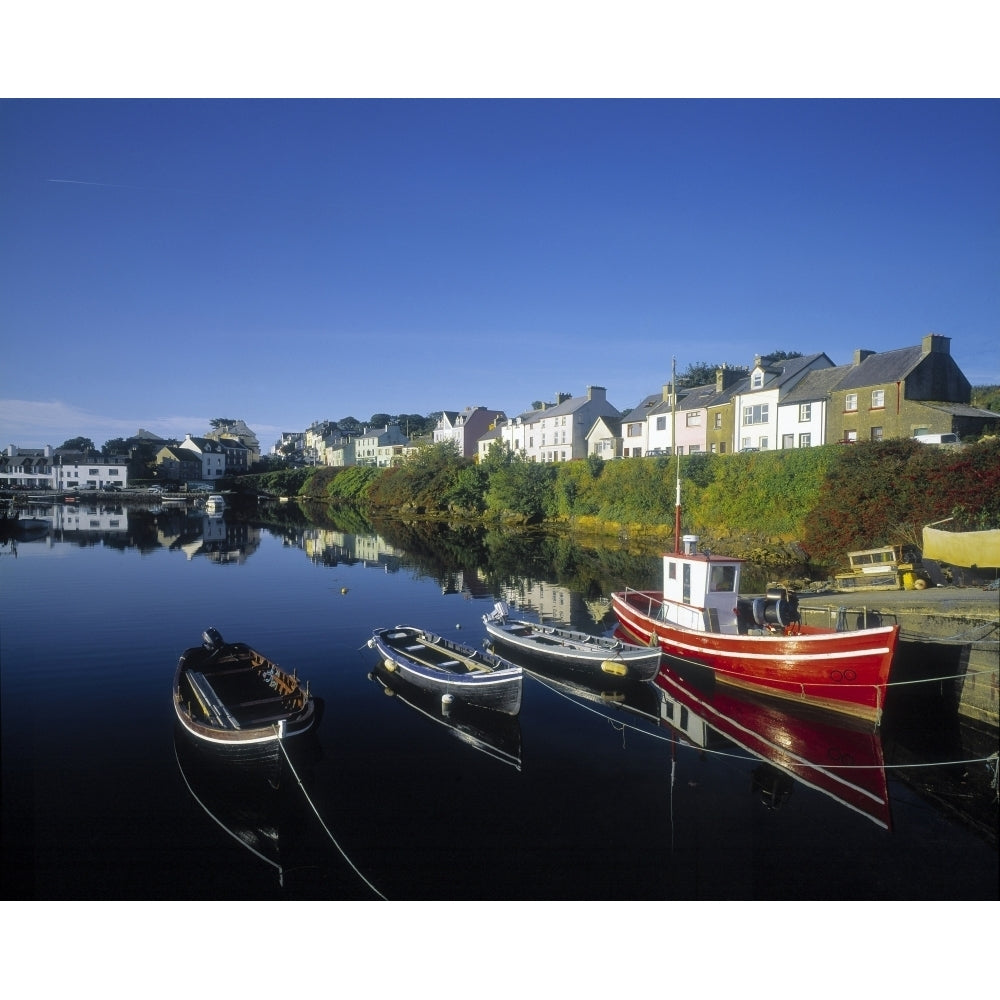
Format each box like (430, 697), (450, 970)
(236, 438), (1000, 569)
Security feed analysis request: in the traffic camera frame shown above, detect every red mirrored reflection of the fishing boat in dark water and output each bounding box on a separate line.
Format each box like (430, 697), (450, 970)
(654, 640), (891, 830)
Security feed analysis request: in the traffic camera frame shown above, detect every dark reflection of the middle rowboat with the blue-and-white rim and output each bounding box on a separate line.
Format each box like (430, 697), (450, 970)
(368, 663), (521, 771)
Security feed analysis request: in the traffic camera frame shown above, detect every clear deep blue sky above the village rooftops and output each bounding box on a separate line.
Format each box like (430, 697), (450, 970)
(0, 98), (1000, 448)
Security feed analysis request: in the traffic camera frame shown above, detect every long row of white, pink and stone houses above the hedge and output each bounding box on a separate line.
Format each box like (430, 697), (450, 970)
(288, 334), (998, 466)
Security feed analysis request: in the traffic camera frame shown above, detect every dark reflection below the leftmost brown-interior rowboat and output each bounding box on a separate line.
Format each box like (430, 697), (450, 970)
(174, 723), (320, 887)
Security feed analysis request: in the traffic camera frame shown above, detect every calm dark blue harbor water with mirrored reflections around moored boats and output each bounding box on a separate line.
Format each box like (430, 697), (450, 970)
(0, 504), (998, 900)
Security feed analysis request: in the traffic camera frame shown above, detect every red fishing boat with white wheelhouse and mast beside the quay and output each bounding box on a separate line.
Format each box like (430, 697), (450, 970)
(611, 356), (899, 723)
